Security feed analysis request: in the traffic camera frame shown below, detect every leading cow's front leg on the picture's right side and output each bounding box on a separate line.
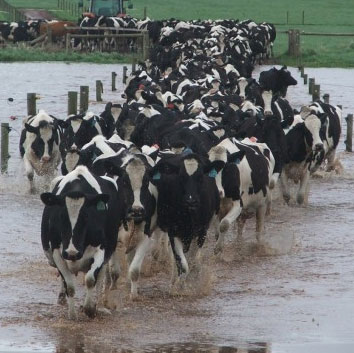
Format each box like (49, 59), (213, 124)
(84, 248), (104, 318)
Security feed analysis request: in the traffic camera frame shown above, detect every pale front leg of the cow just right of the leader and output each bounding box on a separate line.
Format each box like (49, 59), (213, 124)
(128, 234), (151, 300)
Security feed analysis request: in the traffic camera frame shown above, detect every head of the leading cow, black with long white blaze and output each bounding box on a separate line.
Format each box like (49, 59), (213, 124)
(41, 191), (109, 261)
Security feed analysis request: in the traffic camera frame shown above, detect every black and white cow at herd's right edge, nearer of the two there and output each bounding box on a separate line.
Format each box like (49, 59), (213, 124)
(280, 113), (327, 205)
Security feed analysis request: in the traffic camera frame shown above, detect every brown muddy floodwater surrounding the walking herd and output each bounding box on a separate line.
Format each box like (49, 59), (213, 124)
(0, 63), (354, 353)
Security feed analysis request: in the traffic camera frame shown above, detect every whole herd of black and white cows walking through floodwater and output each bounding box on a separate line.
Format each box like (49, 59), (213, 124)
(20, 20), (341, 319)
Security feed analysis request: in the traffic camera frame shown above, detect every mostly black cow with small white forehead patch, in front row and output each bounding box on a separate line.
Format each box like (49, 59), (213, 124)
(152, 153), (220, 283)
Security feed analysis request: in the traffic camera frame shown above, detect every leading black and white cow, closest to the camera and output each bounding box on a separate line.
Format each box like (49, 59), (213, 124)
(41, 166), (122, 319)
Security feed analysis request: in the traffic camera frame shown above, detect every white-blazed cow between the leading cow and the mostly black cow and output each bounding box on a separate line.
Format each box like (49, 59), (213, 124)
(92, 149), (157, 299)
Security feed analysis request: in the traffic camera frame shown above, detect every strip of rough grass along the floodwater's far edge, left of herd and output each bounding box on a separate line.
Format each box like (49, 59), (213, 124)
(0, 48), (135, 64)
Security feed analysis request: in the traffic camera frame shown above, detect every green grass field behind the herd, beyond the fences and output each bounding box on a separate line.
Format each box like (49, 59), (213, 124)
(0, 0), (354, 67)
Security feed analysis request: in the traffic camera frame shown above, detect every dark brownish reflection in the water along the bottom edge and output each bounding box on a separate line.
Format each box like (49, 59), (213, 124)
(56, 334), (271, 353)
